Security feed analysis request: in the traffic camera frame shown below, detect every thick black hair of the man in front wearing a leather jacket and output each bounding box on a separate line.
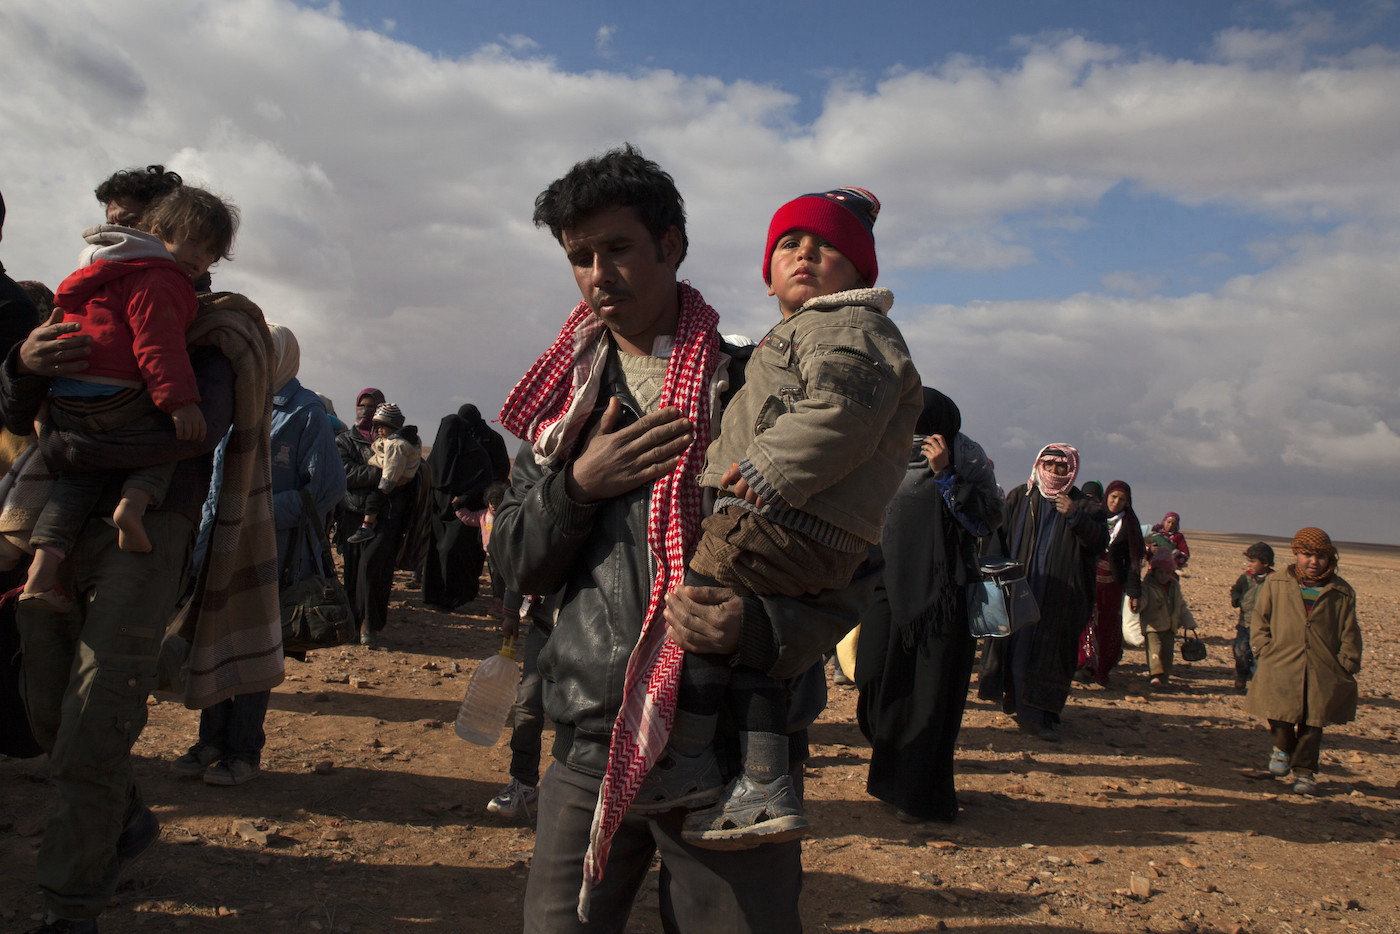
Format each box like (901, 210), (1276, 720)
(535, 143), (690, 266)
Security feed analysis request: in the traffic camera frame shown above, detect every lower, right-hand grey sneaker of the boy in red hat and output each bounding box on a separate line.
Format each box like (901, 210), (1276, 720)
(680, 774), (812, 850)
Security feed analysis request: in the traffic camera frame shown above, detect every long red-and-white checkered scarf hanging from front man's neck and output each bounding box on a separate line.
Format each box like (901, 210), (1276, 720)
(500, 283), (721, 920)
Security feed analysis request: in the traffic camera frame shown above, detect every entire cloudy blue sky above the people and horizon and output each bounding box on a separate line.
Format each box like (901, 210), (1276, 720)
(0, 0), (1400, 542)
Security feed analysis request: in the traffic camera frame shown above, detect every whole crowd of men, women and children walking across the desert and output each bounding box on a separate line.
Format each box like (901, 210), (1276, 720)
(0, 153), (1361, 934)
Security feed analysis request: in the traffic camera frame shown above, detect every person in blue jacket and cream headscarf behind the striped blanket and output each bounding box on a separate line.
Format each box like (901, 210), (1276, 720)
(171, 325), (346, 786)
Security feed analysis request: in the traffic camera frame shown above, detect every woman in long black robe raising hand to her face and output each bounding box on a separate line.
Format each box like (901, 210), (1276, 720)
(855, 386), (1001, 821)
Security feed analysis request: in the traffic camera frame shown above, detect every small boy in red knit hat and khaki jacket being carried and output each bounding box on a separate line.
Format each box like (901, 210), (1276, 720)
(633, 188), (923, 849)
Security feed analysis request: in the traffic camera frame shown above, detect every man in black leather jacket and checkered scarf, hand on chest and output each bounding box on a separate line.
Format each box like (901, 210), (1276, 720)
(491, 146), (872, 933)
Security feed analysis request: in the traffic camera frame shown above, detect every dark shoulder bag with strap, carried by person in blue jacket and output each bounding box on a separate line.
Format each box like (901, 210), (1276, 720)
(277, 490), (356, 653)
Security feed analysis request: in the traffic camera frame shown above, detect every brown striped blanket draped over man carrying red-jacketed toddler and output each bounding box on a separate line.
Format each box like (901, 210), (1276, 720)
(179, 293), (283, 710)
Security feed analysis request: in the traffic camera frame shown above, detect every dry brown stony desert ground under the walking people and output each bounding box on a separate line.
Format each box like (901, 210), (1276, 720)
(0, 532), (1400, 934)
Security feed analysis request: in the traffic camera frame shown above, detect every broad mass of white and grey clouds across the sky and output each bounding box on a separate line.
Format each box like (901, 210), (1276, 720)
(0, 0), (1400, 536)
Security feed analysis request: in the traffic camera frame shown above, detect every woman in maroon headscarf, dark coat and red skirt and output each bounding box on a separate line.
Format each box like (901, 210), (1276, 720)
(1074, 480), (1145, 686)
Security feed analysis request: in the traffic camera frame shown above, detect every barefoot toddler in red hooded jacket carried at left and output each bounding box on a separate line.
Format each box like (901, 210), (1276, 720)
(20, 186), (238, 611)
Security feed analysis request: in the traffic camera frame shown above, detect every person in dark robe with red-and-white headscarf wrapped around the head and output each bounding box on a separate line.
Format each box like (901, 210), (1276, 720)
(977, 444), (1109, 742)
